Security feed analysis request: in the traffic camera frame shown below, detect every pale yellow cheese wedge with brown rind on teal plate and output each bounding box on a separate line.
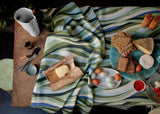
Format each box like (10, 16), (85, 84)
(133, 37), (154, 55)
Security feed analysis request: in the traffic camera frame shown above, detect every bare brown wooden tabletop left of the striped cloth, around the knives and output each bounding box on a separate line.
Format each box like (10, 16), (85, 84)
(11, 22), (49, 107)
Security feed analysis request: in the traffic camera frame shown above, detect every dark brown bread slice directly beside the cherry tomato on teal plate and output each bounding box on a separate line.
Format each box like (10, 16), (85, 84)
(126, 56), (135, 74)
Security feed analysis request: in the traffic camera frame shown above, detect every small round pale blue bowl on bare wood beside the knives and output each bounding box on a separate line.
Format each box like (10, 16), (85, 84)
(26, 65), (37, 76)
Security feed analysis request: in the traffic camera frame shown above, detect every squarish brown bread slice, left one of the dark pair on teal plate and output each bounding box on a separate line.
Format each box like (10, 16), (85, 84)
(116, 57), (129, 72)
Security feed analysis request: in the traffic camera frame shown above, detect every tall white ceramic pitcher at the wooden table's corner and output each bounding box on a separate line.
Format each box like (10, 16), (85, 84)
(14, 8), (40, 37)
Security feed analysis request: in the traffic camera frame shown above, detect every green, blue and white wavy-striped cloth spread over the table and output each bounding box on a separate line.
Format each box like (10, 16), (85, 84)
(31, 2), (160, 113)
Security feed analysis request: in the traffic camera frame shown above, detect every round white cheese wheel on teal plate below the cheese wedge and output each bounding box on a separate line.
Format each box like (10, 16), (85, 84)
(139, 55), (154, 69)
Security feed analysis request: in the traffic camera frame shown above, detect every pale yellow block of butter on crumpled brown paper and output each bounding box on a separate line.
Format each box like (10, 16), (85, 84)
(55, 65), (70, 78)
